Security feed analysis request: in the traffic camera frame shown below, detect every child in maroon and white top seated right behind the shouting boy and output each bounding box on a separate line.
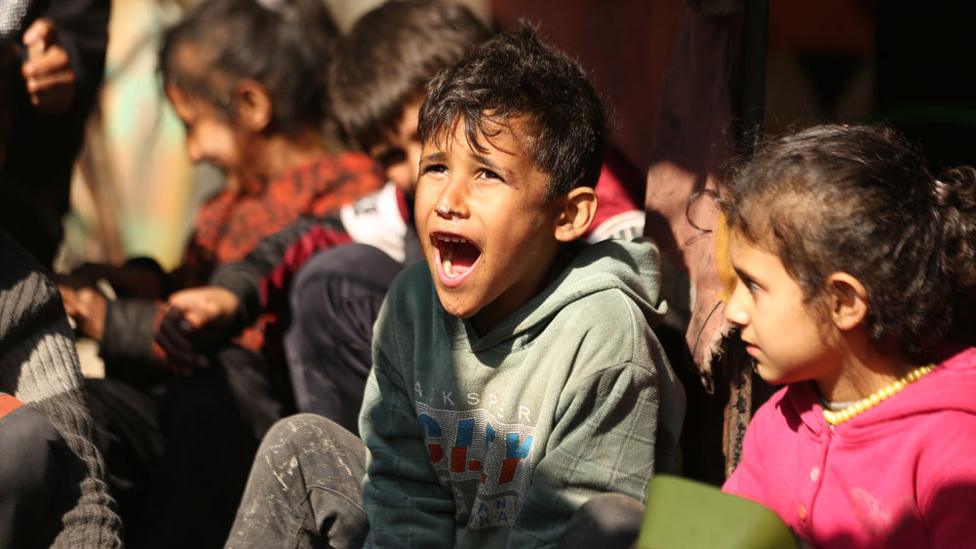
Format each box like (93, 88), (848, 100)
(161, 0), (644, 432)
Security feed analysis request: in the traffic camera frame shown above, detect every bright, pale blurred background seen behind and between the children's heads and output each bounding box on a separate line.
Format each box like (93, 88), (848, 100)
(56, 0), (492, 272)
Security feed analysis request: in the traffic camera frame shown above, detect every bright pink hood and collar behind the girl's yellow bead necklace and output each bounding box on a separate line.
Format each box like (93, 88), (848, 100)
(782, 347), (976, 440)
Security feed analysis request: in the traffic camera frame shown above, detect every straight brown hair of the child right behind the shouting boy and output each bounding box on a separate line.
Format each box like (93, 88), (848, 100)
(330, 0), (490, 150)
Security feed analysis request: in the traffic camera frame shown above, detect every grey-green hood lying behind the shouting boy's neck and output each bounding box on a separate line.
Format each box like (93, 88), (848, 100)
(464, 240), (667, 351)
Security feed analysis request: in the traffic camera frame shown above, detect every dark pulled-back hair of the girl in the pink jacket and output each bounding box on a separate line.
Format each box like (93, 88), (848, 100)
(722, 125), (976, 360)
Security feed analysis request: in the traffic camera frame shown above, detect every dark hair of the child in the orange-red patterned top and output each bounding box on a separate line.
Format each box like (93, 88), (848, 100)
(159, 0), (338, 134)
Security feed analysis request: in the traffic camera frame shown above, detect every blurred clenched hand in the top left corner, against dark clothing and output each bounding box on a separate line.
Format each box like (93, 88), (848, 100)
(21, 18), (77, 114)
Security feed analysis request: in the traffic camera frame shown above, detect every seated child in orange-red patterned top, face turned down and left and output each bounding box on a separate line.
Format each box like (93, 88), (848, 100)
(54, 0), (382, 549)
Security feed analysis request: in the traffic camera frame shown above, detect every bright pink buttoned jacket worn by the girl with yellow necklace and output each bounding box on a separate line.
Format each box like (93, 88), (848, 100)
(723, 348), (976, 548)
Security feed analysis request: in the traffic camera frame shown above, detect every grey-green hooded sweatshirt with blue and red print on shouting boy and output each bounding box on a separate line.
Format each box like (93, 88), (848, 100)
(360, 241), (685, 548)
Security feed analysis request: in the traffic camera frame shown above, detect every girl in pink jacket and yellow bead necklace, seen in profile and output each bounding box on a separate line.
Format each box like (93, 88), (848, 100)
(723, 126), (976, 548)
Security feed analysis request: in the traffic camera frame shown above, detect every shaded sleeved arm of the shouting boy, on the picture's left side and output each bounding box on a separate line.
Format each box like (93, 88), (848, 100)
(359, 349), (455, 548)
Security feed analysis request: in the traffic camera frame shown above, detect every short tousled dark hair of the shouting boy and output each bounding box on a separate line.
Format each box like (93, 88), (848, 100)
(418, 23), (606, 198)
